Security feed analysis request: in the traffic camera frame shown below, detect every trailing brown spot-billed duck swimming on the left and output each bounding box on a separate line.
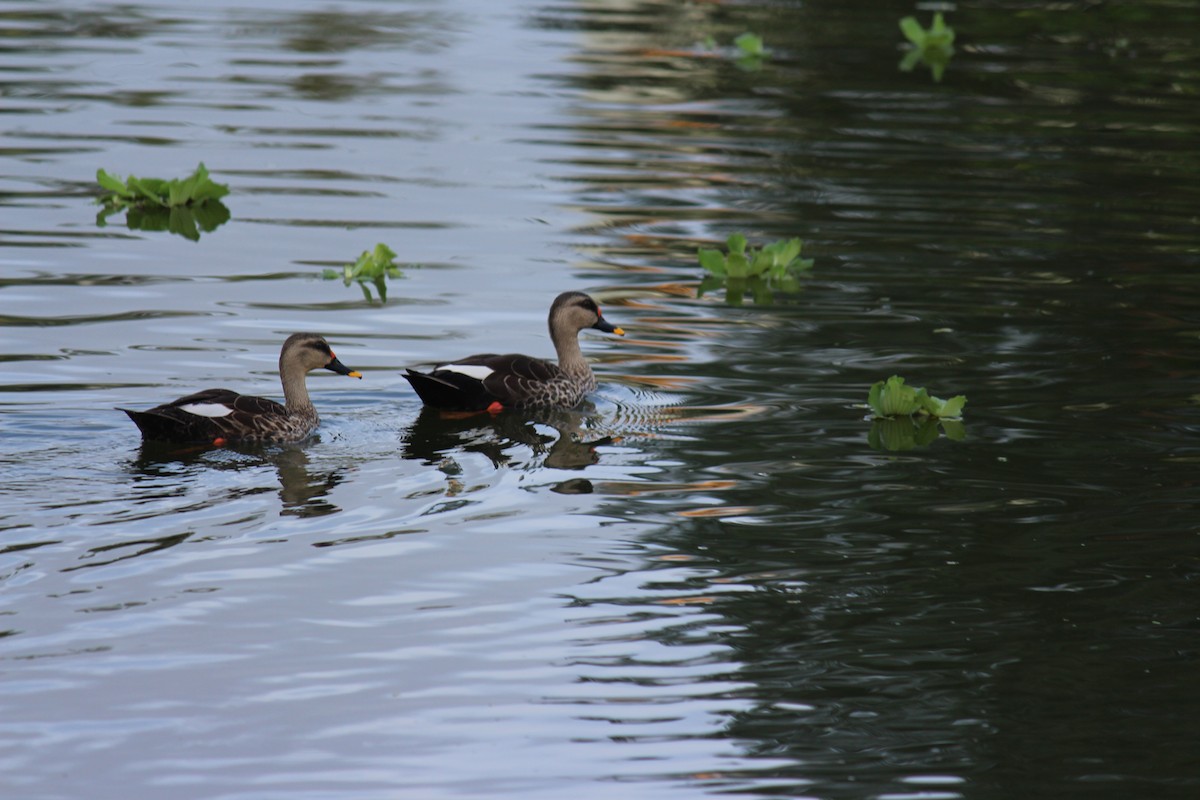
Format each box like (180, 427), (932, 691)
(116, 333), (362, 446)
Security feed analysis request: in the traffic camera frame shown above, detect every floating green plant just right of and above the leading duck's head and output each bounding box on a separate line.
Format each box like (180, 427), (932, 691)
(696, 234), (812, 305)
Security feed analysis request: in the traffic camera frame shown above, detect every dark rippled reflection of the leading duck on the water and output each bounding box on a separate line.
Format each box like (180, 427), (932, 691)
(402, 405), (613, 473)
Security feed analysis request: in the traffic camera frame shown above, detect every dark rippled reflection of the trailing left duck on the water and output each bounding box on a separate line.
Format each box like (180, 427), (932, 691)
(131, 441), (346, 517)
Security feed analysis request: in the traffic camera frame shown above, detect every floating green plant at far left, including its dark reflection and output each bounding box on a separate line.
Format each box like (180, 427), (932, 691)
(96, 163), (229, 241)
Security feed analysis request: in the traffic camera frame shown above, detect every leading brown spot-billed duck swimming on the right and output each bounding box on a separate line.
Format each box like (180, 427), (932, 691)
(404, 291), (625, 414)
